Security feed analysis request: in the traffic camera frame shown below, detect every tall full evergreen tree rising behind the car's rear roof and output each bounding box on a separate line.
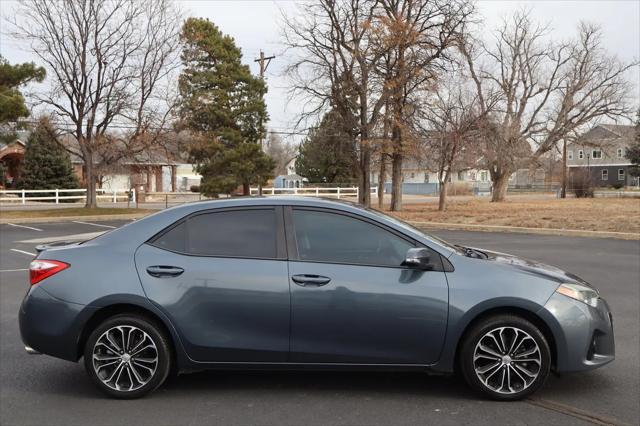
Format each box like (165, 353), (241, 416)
(179, 18), (275, 196)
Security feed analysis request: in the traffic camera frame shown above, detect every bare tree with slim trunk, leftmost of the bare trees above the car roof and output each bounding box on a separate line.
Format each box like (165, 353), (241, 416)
(284, 0), (387, 206)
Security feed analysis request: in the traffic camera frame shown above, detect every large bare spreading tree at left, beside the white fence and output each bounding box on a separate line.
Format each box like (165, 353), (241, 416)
(12, 0), (180, 207)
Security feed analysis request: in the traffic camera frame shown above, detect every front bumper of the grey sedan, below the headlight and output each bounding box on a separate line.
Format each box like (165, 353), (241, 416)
(538, 293), (615, 373)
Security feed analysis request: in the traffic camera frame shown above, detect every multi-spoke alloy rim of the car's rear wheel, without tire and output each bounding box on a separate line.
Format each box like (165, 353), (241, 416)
(92, 325), (158, 392)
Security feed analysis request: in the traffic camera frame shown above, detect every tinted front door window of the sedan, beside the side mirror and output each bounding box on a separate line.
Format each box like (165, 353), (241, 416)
(293, 210), (414, 266)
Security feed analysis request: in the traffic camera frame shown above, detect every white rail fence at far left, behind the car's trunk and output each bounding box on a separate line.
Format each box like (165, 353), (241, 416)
(0, 188), (136, 204)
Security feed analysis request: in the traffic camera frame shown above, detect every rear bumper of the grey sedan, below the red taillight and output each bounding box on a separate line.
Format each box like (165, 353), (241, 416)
(18, 285), (95, 361)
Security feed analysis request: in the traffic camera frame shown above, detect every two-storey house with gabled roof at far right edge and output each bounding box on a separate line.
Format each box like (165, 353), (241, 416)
(567, 124), (638, 187)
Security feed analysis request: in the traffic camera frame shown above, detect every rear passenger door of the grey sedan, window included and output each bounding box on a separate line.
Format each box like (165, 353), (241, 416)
(136, 207), (290, 362)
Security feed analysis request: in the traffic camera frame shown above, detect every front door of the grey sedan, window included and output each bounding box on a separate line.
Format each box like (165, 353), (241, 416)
(286, 208), (448, 364)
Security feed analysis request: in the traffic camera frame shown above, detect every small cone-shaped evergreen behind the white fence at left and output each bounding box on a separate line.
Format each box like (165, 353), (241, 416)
(18, 119), (78, 194)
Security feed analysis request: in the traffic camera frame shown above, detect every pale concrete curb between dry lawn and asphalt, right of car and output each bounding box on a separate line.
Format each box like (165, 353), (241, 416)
(408, 221), (640, 240)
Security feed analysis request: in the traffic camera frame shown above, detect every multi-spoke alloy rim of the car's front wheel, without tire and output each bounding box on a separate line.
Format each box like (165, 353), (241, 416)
(473, 327), (542, 394)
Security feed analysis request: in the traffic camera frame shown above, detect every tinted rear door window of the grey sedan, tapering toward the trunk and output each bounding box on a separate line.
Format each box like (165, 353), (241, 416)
(153, 209), (277, 258)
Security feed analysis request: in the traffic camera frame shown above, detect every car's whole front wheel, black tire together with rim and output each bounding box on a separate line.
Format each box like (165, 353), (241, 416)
(458, 315), (551, 401)
